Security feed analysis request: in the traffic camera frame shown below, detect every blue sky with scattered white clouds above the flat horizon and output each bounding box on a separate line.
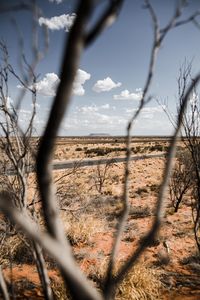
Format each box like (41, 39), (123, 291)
(0, 0), (200, 136)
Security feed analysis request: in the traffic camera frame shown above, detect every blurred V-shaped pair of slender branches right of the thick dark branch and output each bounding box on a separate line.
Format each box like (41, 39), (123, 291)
(104, 0), (199, 297)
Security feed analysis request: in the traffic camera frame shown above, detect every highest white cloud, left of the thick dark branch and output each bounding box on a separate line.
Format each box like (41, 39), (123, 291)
(38, 13), (76, 31)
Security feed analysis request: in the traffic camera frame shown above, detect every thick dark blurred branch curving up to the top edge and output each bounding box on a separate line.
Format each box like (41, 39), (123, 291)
(37, 1), (125, 244)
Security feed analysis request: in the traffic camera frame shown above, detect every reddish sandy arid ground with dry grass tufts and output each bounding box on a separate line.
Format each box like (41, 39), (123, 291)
(0, 138), (200, 300)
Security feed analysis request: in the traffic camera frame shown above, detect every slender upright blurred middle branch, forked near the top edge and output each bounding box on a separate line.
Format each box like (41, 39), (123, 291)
(104, 0), (200, 294)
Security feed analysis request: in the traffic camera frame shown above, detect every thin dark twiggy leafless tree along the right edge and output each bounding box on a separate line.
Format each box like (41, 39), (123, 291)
(166, 62), (200, 251)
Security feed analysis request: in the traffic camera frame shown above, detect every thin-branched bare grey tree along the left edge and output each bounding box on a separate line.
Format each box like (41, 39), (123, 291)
(0, 7), (53, 300)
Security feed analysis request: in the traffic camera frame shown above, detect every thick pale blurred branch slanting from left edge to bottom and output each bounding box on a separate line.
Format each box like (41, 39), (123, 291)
(0, 192), (103, 300)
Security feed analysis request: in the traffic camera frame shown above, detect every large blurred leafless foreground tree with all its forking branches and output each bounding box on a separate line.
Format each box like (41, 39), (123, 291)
(0, 0), (200, 300)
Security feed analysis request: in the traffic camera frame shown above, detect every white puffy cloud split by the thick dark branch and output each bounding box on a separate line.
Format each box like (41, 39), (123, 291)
(30, 69), (91, 96)
